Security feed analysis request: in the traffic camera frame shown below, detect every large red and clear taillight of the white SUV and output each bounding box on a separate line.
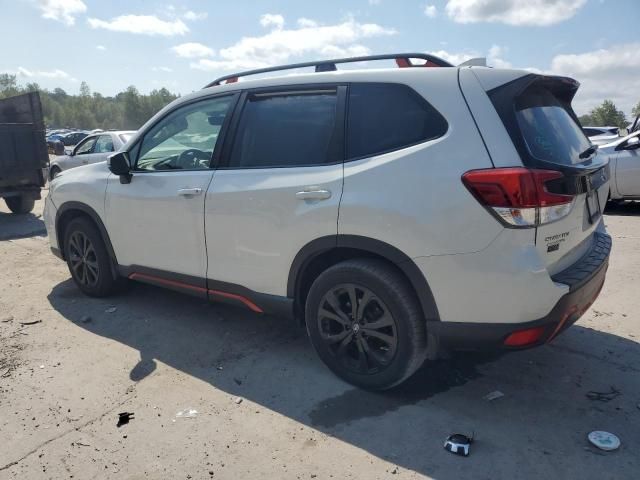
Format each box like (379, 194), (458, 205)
(462, 167), (574, 228)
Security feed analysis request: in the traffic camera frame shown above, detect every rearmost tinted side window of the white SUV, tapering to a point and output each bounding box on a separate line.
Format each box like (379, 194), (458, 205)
(347, 84), (447, 158)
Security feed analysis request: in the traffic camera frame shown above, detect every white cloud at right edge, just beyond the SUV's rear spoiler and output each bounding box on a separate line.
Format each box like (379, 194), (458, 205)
(549, 42), (640, 114)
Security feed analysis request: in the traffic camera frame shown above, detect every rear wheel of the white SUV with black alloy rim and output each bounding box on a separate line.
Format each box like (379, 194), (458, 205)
(305, 259), (427, 390)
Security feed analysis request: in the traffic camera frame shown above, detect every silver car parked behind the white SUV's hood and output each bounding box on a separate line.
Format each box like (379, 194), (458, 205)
(49, 131), (135, 180)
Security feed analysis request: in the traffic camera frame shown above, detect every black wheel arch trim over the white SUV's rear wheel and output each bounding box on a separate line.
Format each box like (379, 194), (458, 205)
(287, 235), (440, 321)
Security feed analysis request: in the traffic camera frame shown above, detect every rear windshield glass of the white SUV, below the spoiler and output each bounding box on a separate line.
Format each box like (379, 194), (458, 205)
(516, 87), (591, 165)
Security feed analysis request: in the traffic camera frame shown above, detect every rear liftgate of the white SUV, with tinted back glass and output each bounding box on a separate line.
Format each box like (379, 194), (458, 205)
(489, 75), (610, 275)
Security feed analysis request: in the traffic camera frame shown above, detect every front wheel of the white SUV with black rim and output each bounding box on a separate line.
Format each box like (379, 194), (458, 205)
(64, 218), (117, 297)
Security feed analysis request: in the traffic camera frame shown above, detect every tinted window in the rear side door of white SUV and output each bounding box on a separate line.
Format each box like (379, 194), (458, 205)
(230, 90), (342, 168)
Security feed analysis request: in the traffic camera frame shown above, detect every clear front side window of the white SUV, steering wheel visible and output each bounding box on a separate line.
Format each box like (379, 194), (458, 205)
(136, 96), (233, 171)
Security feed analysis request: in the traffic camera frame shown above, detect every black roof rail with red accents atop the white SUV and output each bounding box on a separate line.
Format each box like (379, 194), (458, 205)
(204, 53), (453, 88)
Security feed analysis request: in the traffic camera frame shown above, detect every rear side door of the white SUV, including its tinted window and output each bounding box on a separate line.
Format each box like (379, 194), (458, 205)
(205, 85), (346, 296)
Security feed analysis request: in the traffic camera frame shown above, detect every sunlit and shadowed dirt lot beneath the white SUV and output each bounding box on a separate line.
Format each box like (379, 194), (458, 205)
(0, 197), (640, 480)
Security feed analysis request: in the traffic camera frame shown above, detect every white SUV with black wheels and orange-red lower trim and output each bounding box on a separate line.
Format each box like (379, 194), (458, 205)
(45, 54), (611, 389)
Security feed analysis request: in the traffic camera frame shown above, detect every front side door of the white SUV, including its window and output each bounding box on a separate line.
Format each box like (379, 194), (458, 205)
(106, 95), (235, 287)
